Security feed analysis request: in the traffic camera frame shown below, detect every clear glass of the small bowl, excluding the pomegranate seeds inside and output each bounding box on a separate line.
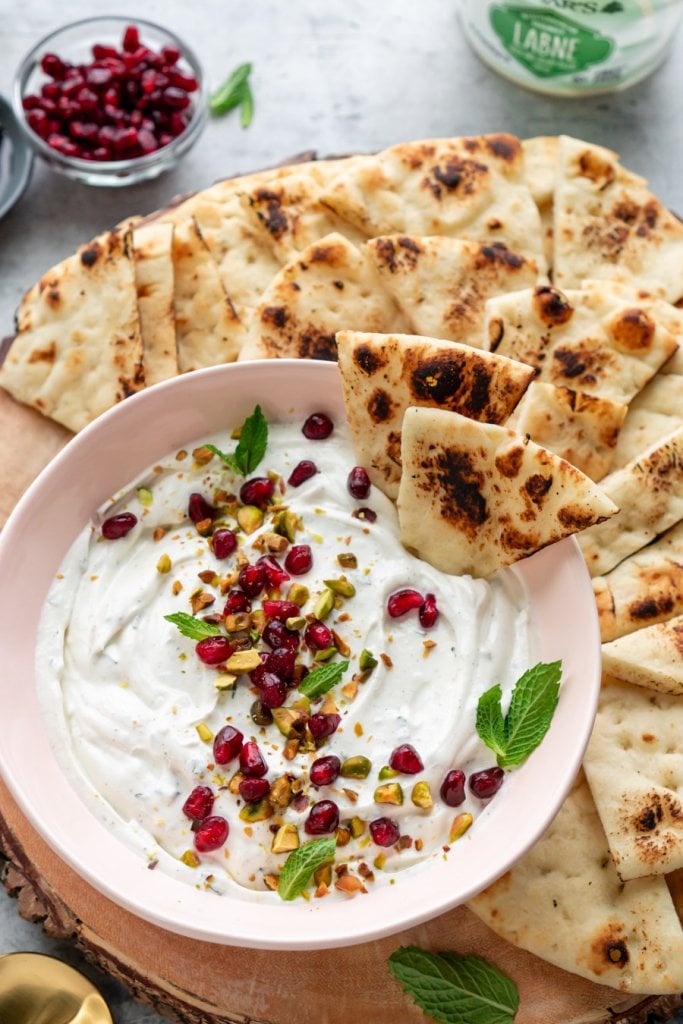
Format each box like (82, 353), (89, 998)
(12, 15), (207, 187)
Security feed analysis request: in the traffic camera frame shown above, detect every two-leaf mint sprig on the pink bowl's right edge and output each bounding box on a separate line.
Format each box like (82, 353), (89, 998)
(476, 662), (562, 768)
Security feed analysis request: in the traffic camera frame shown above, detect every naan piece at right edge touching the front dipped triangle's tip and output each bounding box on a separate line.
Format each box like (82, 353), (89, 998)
(579, 428), (683, 577)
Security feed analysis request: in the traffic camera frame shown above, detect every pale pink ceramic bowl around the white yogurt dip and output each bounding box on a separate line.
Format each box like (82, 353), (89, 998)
(0, 359), (600, 949)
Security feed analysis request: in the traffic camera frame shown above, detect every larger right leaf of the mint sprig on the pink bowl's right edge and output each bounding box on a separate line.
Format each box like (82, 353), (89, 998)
(498, 662), (562, 768)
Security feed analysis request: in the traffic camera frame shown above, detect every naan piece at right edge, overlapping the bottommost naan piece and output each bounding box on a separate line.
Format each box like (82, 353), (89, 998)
(584, 679), (683, 882)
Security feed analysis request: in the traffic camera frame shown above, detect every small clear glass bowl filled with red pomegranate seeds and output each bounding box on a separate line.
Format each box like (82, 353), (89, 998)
(13, 16), (207, 186)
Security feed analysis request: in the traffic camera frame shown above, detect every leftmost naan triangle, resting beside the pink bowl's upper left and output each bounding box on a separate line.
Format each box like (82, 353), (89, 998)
(0, 230), (144, 430)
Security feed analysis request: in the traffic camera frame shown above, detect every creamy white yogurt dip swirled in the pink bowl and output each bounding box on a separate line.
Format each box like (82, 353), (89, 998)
(37, 411), (536, 899)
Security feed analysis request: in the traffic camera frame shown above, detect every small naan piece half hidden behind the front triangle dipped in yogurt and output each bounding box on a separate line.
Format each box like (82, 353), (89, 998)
(507, 381), (628, 480)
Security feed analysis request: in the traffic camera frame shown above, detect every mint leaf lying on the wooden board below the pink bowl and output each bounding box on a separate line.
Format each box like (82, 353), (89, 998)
(389, 946), (519, 1024)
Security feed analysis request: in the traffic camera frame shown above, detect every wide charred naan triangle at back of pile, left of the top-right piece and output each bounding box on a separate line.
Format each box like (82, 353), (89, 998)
(324, 134), (543, 266)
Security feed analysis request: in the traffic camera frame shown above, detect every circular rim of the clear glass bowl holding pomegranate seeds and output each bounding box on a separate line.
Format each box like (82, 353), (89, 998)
(12, 14), (208, 177)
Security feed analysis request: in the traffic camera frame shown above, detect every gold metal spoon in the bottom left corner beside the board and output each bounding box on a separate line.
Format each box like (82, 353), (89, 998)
(0, 953), (113, 1024)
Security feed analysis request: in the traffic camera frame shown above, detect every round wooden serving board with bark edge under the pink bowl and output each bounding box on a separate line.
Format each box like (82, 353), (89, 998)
(0, 389), (683, 1024)
